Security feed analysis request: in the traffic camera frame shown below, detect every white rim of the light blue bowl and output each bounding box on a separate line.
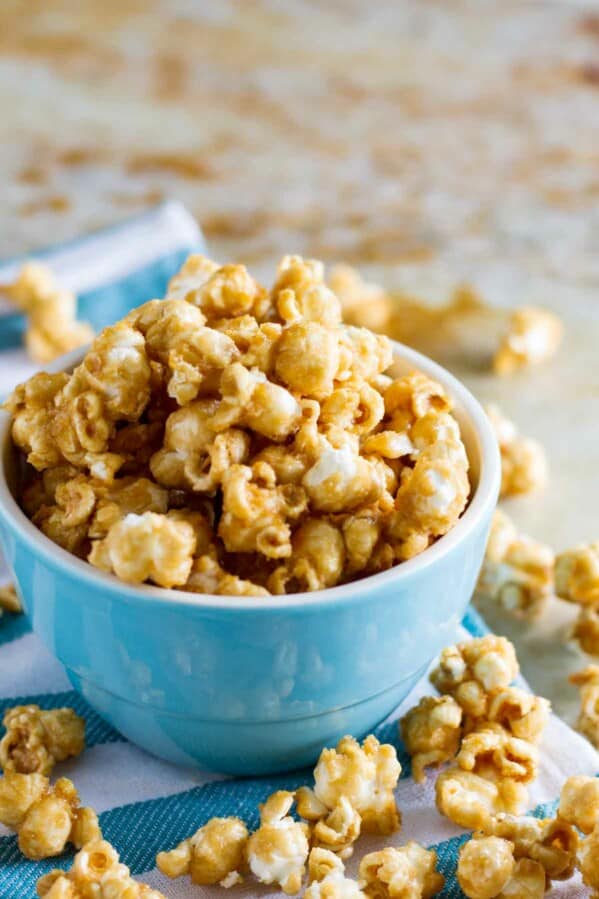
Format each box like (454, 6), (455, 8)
(0, 340), (501, 612)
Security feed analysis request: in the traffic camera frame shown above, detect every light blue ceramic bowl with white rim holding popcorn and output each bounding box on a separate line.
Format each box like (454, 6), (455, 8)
(0, 344), (500, 775)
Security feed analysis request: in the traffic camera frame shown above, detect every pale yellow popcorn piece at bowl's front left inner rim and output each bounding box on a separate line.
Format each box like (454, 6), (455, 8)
(88, 512), (196, 587)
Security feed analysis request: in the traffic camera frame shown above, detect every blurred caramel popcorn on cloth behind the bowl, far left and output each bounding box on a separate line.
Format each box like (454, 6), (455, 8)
(1, 262), (94, 362)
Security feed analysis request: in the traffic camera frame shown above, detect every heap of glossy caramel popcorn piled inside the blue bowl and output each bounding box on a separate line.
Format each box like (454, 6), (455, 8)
(7, 256), (470, 595)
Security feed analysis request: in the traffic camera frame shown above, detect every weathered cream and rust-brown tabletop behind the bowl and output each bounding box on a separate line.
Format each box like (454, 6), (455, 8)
(0, 0), (599, 720)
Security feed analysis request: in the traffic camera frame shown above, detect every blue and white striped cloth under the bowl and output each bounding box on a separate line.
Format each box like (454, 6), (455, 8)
(0, 204), (599, 899)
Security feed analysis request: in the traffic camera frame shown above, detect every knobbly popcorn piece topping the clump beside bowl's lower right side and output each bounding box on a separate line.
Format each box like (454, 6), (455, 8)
(430, 634), (519, 718)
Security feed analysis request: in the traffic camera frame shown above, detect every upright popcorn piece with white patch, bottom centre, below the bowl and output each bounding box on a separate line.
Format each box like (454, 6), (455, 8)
(246, 790), (309, 895)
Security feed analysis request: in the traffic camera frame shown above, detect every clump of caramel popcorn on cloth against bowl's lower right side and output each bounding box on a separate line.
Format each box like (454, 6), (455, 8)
(400, 635), (549, 828)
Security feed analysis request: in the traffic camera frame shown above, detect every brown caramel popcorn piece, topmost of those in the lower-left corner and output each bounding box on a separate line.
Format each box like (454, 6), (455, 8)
(0, 705), (85, 775)
